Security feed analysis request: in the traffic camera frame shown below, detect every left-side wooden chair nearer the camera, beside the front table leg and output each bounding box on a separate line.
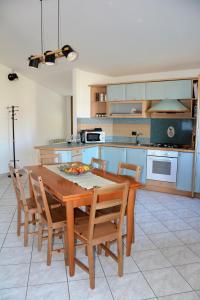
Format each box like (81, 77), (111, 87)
(30, 173), (85, 266)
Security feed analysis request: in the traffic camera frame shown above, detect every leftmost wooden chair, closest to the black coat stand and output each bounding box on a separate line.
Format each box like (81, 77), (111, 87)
(9, 165), (38, 247)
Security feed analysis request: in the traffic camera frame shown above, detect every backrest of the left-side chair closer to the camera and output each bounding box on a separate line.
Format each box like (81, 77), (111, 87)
(30, 173), (52, 225)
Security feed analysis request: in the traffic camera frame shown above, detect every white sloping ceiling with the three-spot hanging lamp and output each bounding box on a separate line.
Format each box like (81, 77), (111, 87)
(0, 0), (200, 95)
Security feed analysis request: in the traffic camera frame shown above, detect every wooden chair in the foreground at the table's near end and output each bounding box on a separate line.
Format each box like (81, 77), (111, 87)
(75, 183), (128, 289)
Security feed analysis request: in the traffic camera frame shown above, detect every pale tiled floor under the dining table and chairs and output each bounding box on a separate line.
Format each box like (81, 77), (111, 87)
(0, 176), (200, 300)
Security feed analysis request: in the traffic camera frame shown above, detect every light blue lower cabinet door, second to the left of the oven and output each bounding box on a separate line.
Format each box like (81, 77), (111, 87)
(101, 147), (126, 174)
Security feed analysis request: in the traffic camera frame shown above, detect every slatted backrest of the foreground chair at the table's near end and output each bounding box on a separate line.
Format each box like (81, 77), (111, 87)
(88, 183), (128, 241)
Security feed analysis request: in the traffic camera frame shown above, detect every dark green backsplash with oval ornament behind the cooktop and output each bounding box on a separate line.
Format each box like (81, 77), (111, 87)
(151, 119), (192, 145)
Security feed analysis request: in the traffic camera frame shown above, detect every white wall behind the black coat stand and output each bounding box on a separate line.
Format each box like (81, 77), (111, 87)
(0, 65), (66, 174)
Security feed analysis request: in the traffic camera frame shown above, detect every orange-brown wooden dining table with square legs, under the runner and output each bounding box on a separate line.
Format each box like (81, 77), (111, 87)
(26, 165), (142, 276)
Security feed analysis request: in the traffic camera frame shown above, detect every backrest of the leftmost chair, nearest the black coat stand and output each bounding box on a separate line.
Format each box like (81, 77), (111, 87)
(9, 164), (28, 211)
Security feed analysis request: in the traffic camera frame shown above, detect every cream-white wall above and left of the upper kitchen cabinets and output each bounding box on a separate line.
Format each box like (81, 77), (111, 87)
(73, 69), (200, 127)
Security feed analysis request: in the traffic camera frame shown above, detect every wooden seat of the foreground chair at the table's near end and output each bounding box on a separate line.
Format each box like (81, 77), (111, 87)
(75, 216), (117, 241)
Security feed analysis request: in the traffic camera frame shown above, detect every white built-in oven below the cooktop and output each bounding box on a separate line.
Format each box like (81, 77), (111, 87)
(147, 150), (178, 182)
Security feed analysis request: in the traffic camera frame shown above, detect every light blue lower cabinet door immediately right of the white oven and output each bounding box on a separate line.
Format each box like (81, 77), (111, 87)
(176, 152), (193, 191)
